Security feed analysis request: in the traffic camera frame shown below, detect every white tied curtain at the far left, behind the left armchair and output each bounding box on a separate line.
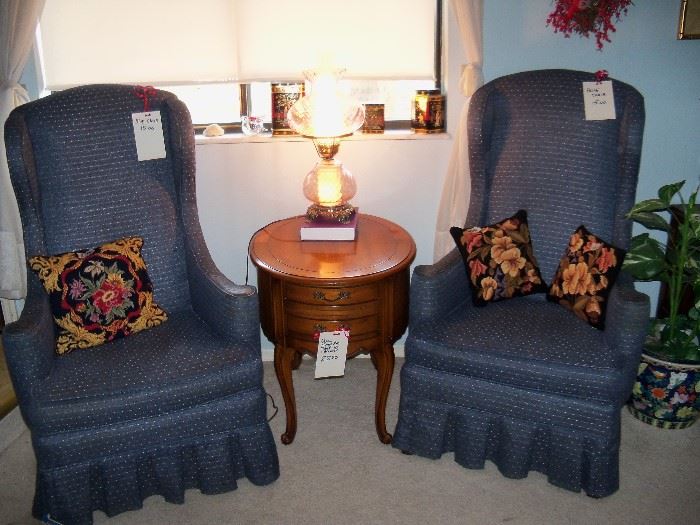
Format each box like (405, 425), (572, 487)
(0, 0), (44, 322)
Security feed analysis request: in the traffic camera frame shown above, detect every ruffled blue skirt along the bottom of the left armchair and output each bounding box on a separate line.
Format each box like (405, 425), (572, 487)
(33, 388), (279, 525)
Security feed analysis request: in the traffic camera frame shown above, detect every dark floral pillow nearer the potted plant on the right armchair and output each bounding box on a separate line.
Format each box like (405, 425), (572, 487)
(547, 225), (625, 330)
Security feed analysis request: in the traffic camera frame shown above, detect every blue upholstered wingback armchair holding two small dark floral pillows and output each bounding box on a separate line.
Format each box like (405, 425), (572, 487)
(393, 70), (649, 497)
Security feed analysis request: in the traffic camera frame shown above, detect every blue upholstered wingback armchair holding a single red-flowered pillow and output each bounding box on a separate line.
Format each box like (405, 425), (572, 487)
(3, 85), (279, 525)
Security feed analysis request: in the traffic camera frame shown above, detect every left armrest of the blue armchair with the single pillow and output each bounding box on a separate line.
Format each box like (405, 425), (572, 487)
(2, 276), (56, 405)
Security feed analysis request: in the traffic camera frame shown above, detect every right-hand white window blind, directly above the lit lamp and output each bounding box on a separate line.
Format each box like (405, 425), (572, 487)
(236, 0), (436, 81)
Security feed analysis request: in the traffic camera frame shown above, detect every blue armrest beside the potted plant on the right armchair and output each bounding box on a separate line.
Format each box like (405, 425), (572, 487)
(604, 272), (650, 388)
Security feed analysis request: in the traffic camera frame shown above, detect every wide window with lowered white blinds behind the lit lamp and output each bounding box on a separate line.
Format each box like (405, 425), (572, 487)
(39, 0), (441, 127)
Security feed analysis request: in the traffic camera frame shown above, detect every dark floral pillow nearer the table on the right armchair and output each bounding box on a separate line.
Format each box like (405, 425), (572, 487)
(450, 210), (547, 306)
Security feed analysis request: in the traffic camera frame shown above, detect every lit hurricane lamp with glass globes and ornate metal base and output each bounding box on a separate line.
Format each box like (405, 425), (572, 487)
(287, 70), (365, 223)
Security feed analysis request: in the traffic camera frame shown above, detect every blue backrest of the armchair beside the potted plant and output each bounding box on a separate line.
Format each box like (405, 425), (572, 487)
(466, 70), (644, 281)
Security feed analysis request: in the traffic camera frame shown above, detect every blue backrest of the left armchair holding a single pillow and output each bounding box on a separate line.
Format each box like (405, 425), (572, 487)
(5, 85), (194, 311)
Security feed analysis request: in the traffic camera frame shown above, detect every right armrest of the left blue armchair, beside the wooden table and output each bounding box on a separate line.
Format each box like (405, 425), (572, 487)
(187, 239), (260, 348)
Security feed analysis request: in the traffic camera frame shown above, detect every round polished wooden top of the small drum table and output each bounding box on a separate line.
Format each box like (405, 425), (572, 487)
(249, 214), (416, 280)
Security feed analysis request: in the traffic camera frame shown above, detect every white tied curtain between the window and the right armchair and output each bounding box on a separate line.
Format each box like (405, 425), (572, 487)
(433, 0), (484, 261)
